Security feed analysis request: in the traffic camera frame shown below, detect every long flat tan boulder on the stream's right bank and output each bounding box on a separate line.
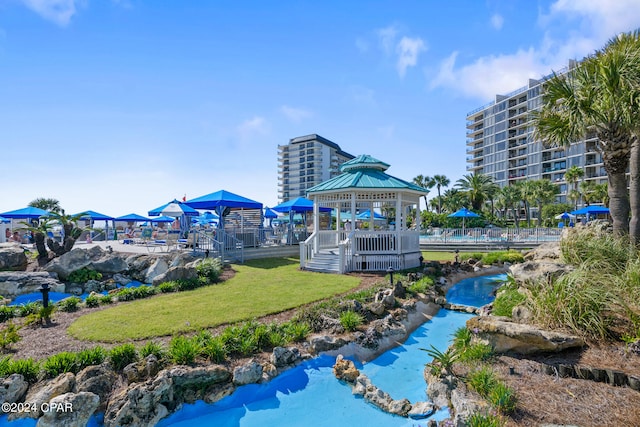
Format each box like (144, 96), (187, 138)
(467, 316), (585, 354)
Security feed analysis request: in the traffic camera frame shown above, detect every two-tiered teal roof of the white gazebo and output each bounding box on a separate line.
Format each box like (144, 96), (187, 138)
(307, 154), (428, 194)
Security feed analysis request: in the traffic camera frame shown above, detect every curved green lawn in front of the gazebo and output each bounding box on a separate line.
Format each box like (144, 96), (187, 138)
(68, 258), (360, 342)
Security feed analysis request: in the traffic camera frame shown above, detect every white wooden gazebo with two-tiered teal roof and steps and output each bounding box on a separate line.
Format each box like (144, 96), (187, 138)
(300, 154), (428, 273)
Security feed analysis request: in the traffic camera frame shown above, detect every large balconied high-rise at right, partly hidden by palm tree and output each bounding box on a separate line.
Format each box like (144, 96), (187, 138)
(467, 61), (607, 203)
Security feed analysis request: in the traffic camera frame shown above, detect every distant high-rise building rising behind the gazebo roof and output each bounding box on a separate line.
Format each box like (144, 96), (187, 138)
(278, 134), (355, 203)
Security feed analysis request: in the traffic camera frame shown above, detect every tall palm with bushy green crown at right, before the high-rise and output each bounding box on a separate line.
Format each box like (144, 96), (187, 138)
(534, 31), (640, 237)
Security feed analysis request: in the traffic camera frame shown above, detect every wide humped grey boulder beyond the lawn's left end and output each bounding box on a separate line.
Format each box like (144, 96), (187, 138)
(45, 246), (129, 280)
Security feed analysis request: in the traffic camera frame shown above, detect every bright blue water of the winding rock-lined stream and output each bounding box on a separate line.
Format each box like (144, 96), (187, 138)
(0, 275), (506, 427)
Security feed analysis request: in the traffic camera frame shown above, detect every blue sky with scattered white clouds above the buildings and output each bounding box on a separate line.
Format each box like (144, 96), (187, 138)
(0, 0), (640, 216)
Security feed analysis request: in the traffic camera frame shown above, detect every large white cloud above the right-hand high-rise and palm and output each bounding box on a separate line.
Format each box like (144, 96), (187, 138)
(430, 0), (640, 101)
